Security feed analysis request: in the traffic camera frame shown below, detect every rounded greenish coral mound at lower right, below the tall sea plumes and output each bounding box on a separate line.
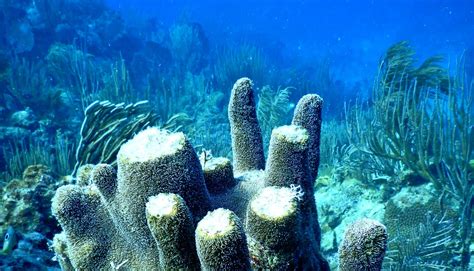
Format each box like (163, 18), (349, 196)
(383, 183), (460, 270)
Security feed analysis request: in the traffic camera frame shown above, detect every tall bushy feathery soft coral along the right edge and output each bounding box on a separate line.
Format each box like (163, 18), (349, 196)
(347, 43), (474, 269)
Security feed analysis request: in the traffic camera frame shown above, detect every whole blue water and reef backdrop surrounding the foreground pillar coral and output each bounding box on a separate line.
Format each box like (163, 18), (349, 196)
(0, 0), (474, 270)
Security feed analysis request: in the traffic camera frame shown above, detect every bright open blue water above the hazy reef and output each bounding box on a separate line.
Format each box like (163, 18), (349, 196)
(109, 0), (474, 85)
